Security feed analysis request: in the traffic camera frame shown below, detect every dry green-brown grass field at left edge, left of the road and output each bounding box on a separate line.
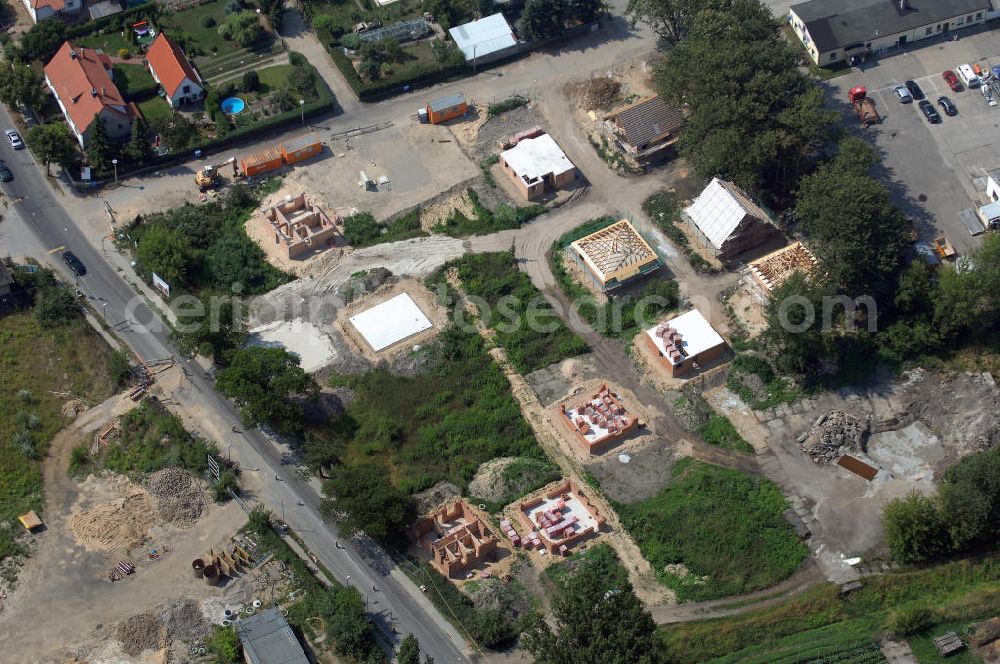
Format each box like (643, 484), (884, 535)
(0, 311), (115, 580)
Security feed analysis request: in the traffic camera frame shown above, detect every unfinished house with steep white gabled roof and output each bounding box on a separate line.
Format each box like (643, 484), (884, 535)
(684, 178), (777, 260)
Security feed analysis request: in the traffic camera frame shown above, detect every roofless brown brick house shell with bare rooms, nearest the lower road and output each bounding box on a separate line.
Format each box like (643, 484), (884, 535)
(412, 500), (497, 579)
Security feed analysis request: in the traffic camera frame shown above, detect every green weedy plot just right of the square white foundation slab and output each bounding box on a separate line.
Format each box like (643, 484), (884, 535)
(449, 252), (587, 374)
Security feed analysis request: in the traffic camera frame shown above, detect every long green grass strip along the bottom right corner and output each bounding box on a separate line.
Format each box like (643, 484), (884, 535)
(659, 554), (1000, 664)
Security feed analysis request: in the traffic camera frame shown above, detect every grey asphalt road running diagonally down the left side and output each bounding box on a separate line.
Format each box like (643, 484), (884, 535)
(0, 105), (470, 663)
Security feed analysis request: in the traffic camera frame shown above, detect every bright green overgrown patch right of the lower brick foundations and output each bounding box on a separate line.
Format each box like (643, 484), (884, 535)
(615, 459), (808, 601)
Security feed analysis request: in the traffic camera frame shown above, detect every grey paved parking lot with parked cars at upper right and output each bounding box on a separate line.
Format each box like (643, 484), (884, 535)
(828, 30), (1000, 253)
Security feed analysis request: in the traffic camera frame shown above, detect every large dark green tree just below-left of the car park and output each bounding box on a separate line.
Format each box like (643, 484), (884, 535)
(795, 138), (907, 303)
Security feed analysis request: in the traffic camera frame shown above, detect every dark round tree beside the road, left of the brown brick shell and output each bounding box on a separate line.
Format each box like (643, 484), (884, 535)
(323, 461), (413, 541)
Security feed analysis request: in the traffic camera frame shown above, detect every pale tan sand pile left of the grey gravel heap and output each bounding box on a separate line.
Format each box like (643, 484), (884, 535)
(69, 485), (155, 551)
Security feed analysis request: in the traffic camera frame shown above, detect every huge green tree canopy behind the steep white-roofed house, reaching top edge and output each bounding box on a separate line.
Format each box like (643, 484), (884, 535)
(656, 0), (838, 205)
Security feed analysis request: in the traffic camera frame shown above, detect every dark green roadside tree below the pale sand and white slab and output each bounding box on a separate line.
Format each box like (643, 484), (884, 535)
(215, 346), (319, 433)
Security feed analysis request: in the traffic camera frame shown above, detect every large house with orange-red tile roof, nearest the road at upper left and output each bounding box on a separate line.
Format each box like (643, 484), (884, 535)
(45, 42), (134, 147)
